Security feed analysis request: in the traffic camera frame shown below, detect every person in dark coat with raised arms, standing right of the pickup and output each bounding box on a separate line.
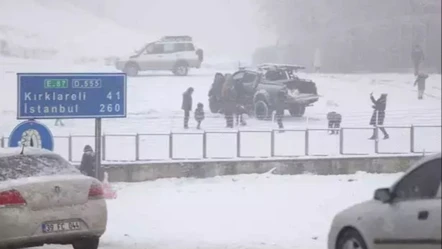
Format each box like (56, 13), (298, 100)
(370, 93), (389, 139)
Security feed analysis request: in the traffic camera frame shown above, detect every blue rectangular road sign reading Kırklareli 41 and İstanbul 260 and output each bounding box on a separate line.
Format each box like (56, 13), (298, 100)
(17, 73), (127, 119)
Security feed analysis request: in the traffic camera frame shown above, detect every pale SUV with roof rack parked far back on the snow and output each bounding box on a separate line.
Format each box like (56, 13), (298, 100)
(115, 36), (203, 76)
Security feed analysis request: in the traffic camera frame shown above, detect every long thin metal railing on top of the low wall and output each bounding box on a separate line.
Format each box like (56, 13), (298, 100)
(0, 125), (441, 162)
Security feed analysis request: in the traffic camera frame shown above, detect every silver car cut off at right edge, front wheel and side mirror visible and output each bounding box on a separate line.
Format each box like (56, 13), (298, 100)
(328, 153), (441, 249)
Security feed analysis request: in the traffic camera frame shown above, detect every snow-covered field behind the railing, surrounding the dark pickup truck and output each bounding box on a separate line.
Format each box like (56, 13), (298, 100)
(0, 60), (441, 161)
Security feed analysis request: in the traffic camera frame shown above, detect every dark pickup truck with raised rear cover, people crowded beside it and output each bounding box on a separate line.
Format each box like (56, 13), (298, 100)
(209, 64), (319, 119)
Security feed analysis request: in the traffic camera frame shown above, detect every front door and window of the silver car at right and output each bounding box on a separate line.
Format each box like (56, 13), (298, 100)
(373, 158), (441, 249)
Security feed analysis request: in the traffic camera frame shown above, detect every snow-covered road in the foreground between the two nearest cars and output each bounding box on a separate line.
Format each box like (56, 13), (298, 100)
(38, 173), (400, 249)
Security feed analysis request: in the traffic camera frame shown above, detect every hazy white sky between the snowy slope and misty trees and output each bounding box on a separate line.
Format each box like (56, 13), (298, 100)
(64, 0), (275, 57)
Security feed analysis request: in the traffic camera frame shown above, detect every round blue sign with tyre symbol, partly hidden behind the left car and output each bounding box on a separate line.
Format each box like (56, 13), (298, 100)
(8, 121), (54, 151)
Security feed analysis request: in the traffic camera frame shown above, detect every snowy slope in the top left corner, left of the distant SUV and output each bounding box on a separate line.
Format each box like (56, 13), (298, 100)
(0, 0), (147, 61)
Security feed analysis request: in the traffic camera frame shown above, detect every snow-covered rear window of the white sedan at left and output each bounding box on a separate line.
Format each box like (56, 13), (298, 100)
(0, 155), (80, 181)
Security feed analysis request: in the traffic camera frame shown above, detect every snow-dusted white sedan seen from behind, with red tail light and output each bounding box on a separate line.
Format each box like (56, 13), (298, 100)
(0, 148), (107, 249)
